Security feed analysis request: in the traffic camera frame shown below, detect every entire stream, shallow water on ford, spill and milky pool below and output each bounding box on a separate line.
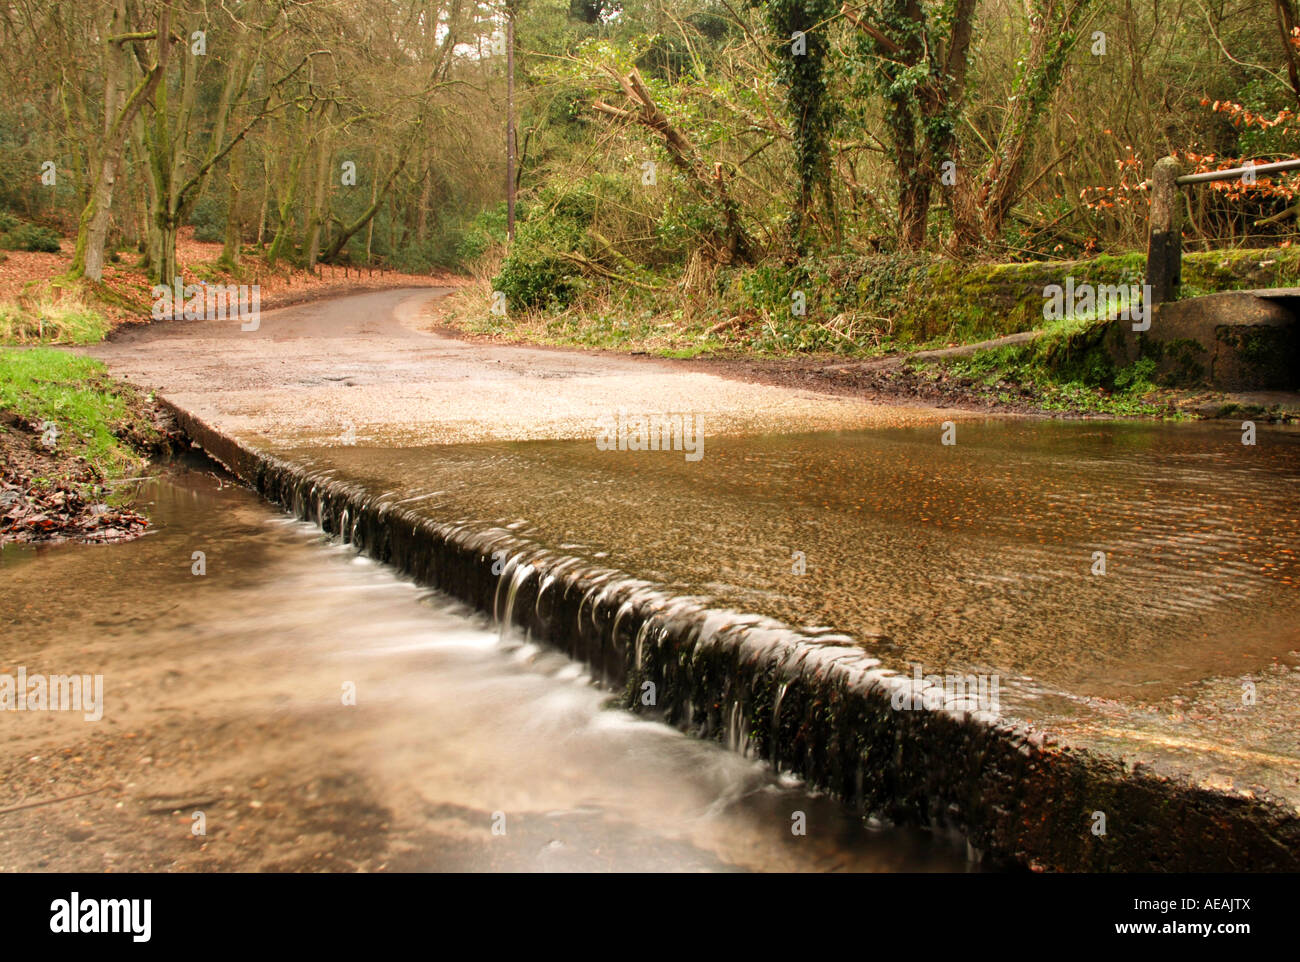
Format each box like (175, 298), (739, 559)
(0, 421), (1300, 870)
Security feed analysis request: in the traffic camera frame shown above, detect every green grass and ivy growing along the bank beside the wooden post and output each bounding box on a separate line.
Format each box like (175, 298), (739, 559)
(447, 248), (1300, 382)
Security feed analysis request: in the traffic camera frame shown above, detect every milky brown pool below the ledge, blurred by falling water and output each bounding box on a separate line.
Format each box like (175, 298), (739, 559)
(0, 462), (969, 871)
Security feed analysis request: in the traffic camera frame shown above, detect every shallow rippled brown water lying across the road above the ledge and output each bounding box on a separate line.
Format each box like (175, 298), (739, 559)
(289, 420), (1300, 701)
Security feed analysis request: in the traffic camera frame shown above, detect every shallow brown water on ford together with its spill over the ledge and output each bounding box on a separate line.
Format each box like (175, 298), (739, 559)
(258, 420), (1300, 821)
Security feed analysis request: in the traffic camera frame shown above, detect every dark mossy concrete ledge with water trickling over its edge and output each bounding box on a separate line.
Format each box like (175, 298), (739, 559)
(159, 397), (1300, 871)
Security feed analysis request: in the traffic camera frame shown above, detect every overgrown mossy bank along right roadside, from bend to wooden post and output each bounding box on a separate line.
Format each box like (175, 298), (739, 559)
(434, 245), (1300, 416)
